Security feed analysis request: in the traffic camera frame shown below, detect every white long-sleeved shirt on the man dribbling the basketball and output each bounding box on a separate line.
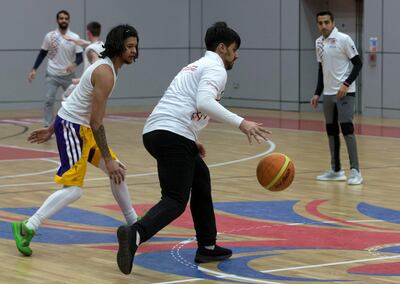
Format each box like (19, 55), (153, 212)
(143, 51), (243, 141)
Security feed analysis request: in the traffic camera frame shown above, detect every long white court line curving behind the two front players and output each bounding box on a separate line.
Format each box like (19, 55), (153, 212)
(0, 138), (276, 188)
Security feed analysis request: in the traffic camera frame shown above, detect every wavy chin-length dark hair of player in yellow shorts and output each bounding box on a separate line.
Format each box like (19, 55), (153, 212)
(101, 25), (139, 60)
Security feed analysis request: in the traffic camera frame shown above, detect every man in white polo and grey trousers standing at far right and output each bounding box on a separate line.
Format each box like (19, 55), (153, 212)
(310, 11), (363, 185)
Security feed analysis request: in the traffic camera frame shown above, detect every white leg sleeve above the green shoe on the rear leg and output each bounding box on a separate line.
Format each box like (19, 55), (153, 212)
(26, 186), (82, 231)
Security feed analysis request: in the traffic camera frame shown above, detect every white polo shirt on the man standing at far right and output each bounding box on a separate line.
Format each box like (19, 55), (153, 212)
(315, 27), (358, 95)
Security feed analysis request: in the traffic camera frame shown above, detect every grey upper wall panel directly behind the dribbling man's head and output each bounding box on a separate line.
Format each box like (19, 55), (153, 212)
(203, 0), (280, 49)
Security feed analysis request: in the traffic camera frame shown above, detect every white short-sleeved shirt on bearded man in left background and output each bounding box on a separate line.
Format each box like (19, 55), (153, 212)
(41, 29), (83, 76)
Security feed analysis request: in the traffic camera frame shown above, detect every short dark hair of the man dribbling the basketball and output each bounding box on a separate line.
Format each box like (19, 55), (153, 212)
(204, 22), (241, 51)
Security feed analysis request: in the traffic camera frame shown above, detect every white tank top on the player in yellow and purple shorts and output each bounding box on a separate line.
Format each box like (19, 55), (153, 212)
(58, 57), (117, 127)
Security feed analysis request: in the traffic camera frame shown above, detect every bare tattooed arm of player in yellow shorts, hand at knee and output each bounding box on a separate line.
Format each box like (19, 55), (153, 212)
(90, 65), (125, 184)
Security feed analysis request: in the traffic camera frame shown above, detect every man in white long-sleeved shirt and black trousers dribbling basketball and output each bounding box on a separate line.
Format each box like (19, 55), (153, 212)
(117, 22), (270, 274)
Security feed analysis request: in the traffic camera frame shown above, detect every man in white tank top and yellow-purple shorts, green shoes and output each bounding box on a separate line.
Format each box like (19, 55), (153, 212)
(12, 25), (139, 256)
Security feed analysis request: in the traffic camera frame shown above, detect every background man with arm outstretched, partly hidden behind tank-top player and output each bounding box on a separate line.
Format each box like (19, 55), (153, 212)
(61, 22), (104, 100)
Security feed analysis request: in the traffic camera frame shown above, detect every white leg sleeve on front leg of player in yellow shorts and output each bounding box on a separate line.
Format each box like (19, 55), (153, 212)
(99, 159), (138, 226)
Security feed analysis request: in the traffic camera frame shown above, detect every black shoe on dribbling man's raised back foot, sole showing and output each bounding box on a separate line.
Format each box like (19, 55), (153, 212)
(117, 226), (138, 274)
